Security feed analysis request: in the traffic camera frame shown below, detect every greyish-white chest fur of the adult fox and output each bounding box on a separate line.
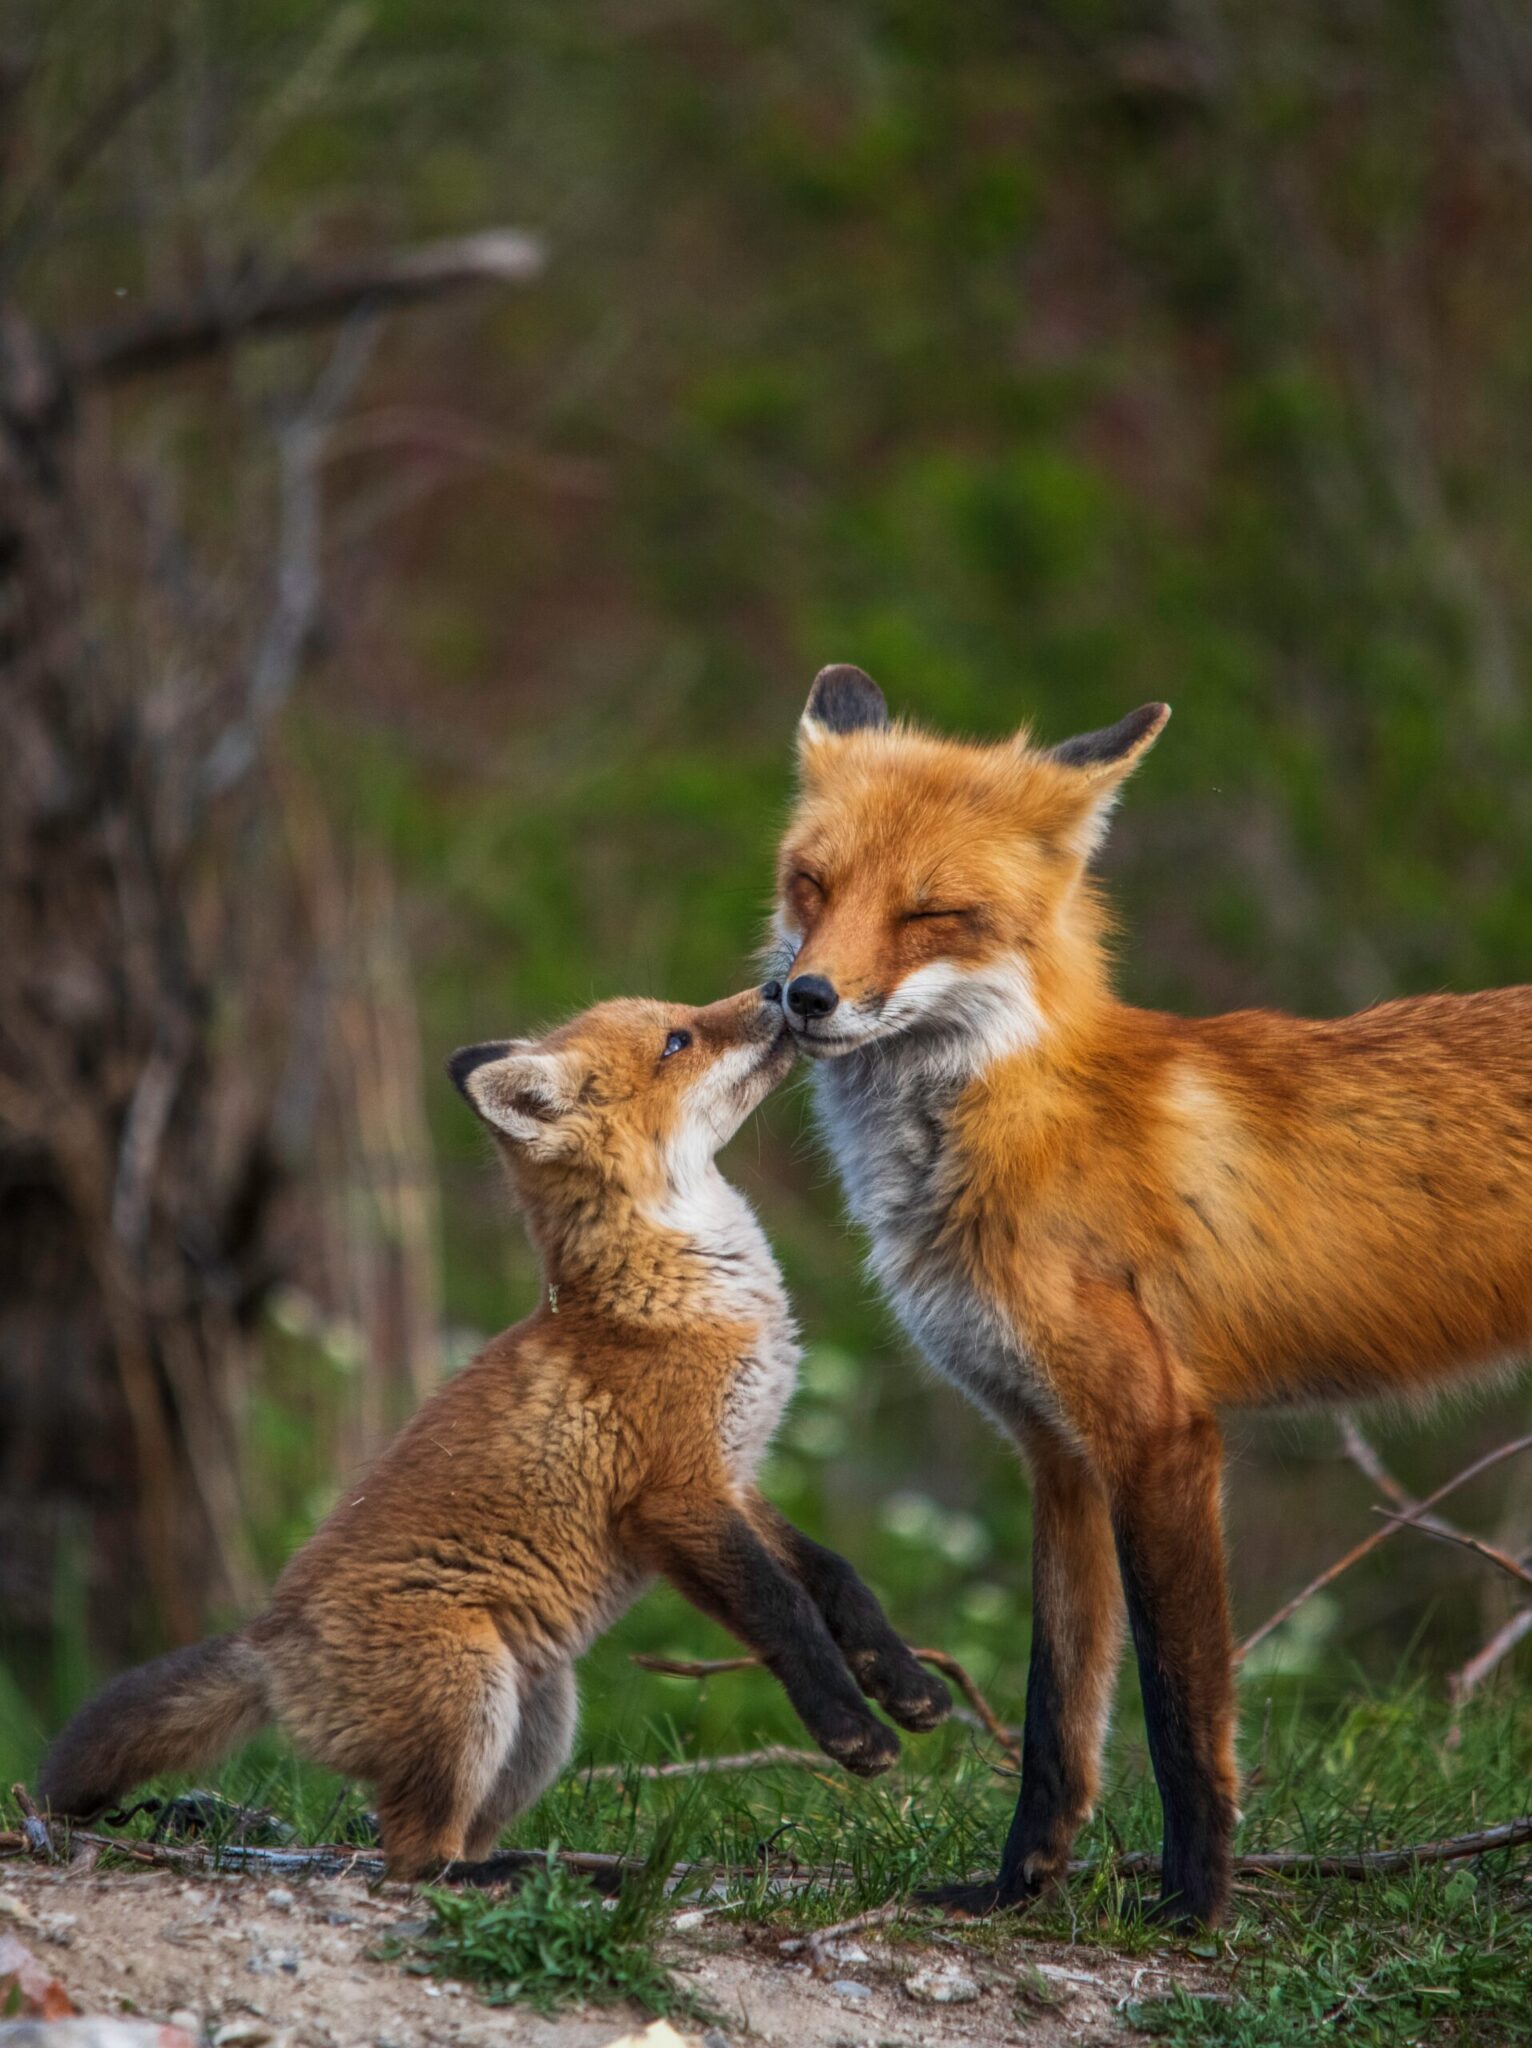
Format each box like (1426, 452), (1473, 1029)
(815, 1038), (1038, 1425)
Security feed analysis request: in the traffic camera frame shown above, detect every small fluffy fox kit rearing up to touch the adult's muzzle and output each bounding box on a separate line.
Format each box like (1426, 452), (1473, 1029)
(41, 985), (950, 1878)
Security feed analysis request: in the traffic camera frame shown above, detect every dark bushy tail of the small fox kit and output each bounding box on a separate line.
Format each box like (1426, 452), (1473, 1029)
(39, 1636), (270, 1821)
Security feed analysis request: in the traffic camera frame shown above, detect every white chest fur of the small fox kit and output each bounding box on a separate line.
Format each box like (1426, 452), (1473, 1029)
(664, 1165), (799, 1483)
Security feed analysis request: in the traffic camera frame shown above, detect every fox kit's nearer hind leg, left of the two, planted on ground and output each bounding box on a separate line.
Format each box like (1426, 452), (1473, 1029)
(375, 1620), (520, 1878)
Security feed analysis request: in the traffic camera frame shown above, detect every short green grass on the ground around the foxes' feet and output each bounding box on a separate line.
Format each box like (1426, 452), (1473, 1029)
(5, 1679), (1532, 2048)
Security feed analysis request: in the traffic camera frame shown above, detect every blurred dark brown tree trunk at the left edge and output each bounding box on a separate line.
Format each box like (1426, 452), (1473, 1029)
(0, 307), (268, 1653)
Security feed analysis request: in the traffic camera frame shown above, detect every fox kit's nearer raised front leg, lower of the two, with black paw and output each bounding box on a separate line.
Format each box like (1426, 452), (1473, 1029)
(633, 1493), (899, 1778)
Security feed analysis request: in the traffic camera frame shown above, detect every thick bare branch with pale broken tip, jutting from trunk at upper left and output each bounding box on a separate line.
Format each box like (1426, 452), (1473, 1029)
(63, 227), (545, 385)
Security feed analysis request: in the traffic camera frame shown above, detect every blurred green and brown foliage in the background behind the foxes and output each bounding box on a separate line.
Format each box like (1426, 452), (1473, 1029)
(2, 0), (1532, 1769)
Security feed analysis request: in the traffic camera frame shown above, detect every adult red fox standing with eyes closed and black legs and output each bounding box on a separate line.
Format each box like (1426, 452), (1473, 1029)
(778, 668), (1532, 1921)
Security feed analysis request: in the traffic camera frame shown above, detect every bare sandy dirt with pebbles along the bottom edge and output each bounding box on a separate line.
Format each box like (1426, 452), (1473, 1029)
(0, 1860), (1208, 2048)
